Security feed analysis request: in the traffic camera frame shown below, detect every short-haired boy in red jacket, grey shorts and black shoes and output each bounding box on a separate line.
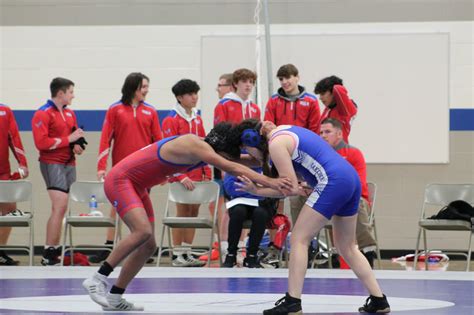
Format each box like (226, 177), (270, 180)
(32, 78), (87, 265)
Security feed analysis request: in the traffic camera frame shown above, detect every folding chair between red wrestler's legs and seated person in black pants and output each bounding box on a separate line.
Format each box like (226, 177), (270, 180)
(156, 181), (222, 267)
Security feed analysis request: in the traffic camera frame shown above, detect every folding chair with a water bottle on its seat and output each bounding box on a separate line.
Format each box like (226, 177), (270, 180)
(61, 181), (120, 265)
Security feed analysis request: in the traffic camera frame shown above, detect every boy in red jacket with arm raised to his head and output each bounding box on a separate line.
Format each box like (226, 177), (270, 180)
(314, 75), (357, 143)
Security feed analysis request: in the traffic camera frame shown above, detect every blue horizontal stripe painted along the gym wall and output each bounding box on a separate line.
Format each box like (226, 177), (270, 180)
(13, 108), (474, 131)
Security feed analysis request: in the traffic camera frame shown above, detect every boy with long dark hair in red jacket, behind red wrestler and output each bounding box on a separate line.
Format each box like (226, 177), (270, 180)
(89, 72), (163, 263)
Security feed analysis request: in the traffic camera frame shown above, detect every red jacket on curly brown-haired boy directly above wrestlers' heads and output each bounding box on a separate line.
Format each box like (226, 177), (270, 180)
(214, 92), (260, 125)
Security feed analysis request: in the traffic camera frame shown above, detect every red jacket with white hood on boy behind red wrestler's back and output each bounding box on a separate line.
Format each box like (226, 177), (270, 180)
(163, 104), (211, 182)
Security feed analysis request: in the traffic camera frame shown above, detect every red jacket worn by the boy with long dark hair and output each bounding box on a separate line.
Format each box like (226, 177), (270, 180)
(97, 101), (163, 171)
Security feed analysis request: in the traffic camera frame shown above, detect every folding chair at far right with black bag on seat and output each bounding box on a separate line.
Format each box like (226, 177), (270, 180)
(414, 184), (474, 271)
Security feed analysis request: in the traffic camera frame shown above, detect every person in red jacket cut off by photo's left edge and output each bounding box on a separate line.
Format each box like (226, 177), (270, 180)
(0, 104), (28, 266)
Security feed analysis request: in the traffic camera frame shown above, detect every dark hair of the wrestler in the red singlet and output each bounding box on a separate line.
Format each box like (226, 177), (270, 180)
(204, 122), (240, 159)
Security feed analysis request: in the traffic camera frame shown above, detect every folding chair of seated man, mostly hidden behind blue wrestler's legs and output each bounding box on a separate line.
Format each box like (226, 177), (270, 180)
(312, 182), (381, 269)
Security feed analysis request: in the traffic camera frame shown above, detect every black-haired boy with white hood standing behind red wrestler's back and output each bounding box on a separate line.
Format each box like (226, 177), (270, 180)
(163, 79), (211, 267)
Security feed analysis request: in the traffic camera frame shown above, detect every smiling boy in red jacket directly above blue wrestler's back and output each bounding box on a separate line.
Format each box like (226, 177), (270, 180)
(263, 64), (320, 134)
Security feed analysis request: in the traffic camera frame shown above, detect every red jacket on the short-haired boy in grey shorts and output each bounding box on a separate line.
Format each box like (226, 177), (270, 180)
(31, 100), (77, 165)
